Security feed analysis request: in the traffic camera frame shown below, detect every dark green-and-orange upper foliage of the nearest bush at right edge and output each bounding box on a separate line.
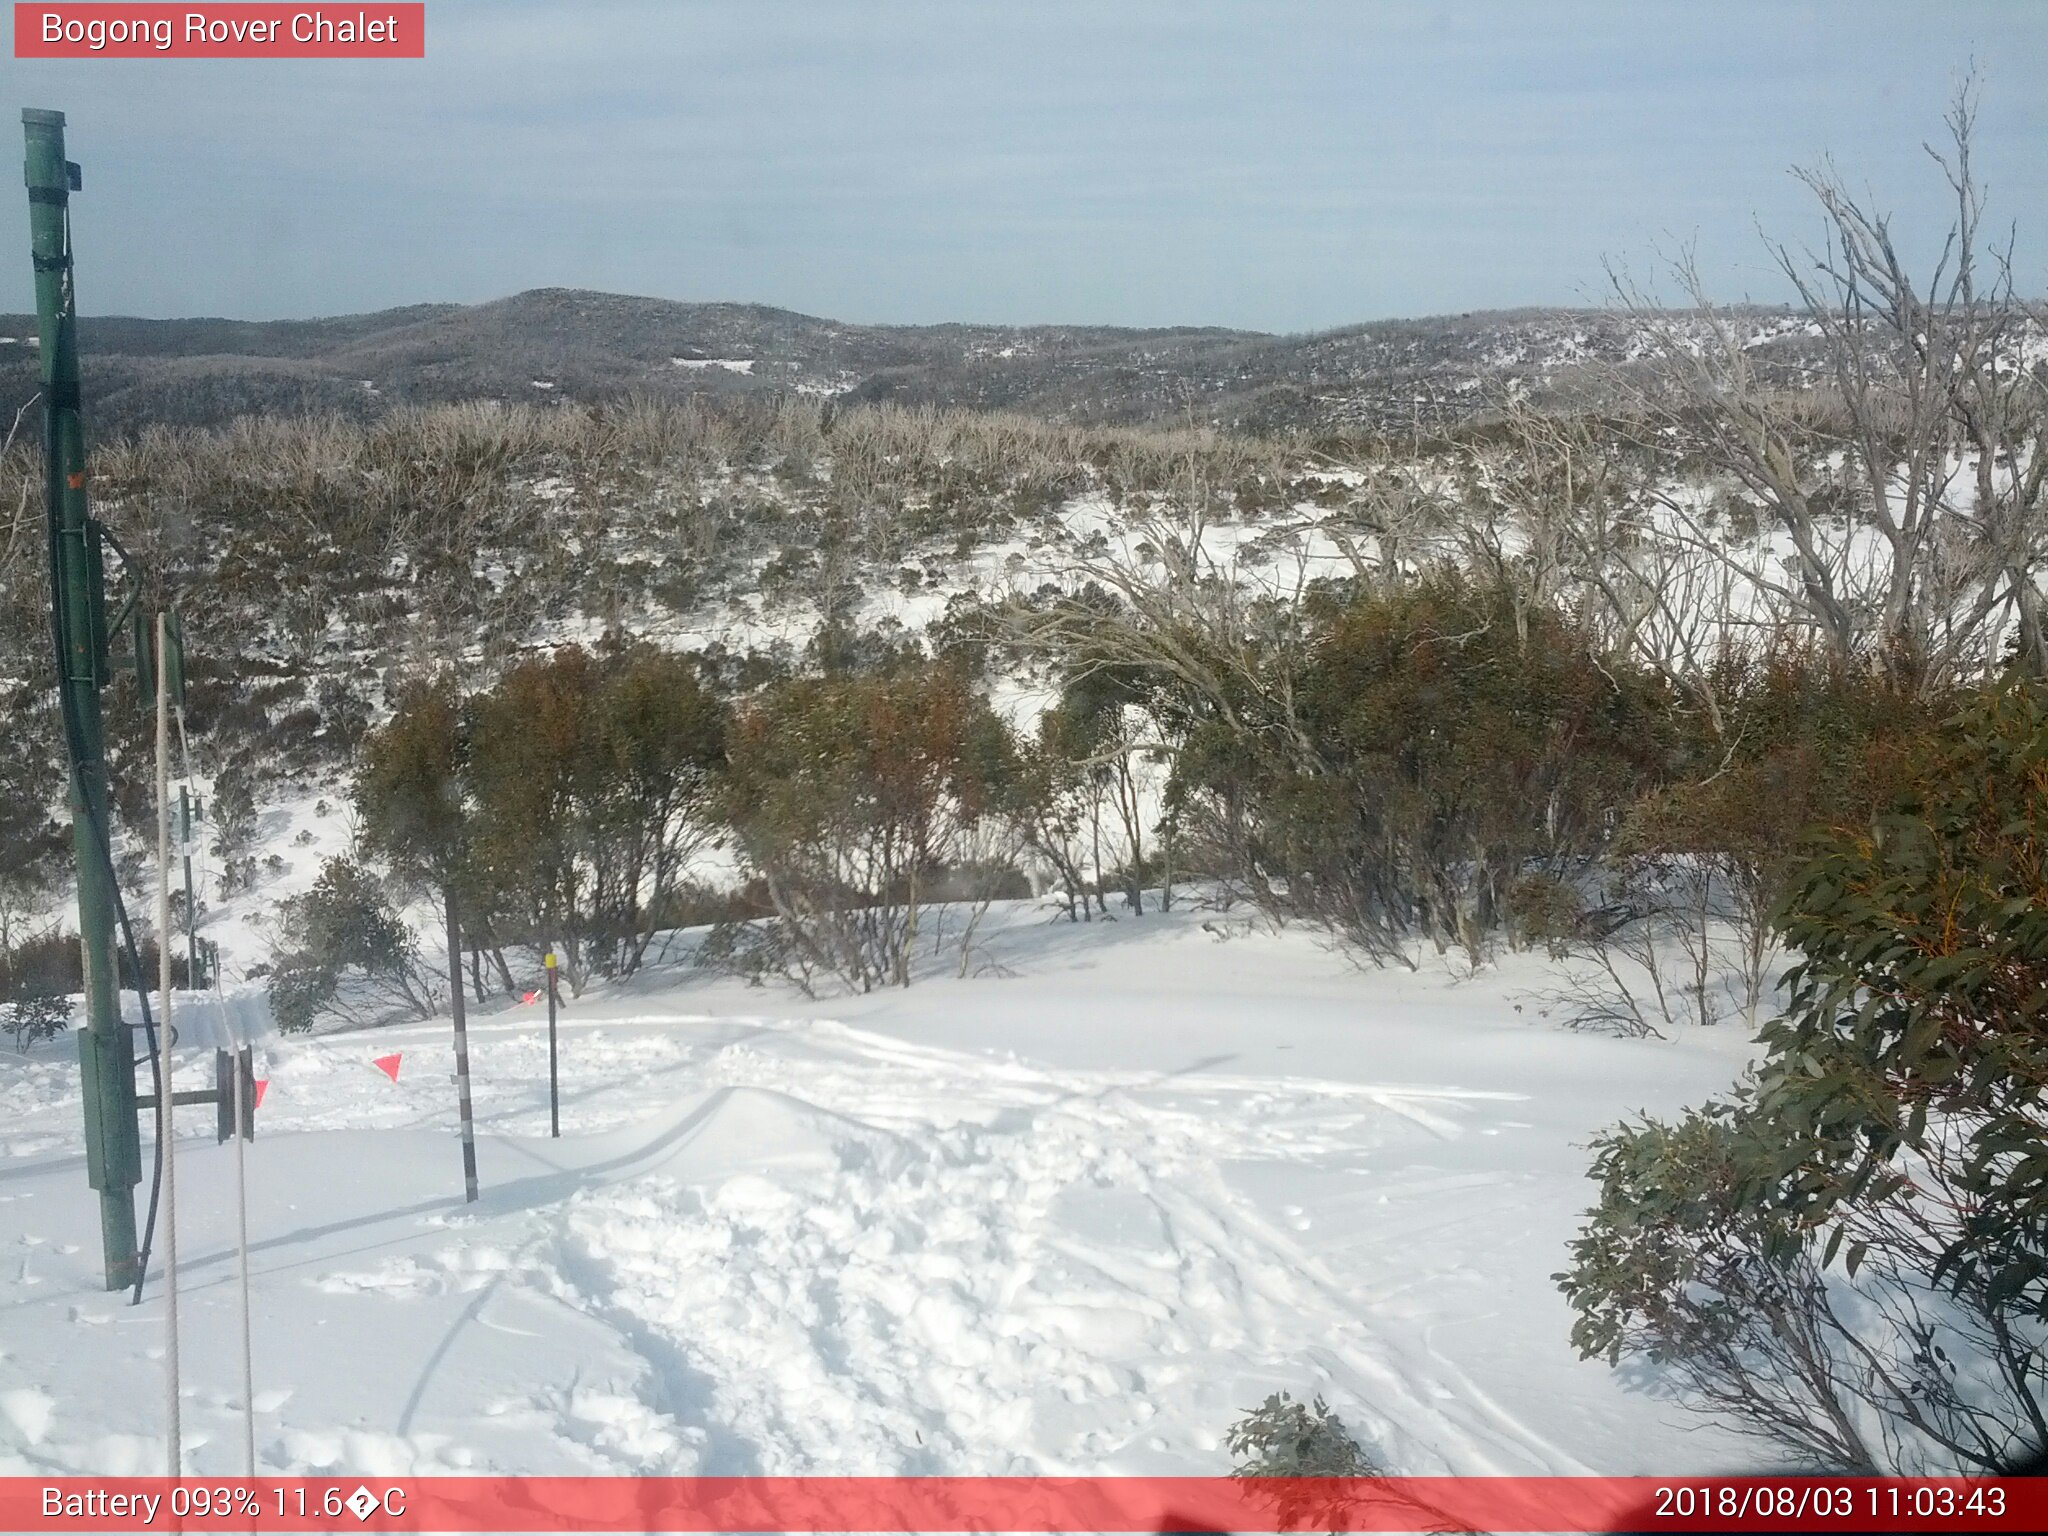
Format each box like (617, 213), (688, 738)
(1761, 682), (2048, 1317)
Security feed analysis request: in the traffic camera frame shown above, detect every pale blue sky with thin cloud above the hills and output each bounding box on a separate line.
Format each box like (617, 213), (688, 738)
(0, 0), (2048, 332)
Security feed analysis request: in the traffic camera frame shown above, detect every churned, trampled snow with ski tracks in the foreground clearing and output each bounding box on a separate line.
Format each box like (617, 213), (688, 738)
(299, 1016), (1585, 1475)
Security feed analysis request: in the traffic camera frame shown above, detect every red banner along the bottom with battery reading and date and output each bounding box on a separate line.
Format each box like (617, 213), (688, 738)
(0, 1477), (2048, 1532)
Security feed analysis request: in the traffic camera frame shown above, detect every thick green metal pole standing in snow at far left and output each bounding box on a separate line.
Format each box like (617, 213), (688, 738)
(20, 106), (141, 1290)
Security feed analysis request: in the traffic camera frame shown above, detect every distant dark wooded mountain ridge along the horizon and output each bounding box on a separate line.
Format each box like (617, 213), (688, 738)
(0, 289), (1794, 432)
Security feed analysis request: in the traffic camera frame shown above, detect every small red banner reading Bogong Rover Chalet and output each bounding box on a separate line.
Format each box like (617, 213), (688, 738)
(14, 0), (426, 59)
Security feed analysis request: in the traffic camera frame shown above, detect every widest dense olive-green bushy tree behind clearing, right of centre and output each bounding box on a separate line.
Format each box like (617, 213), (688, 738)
(1176, 571), (1667, 961)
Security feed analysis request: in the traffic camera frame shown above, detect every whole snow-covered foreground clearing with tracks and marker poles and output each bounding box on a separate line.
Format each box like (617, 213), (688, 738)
(0, 903), (1753, 1475)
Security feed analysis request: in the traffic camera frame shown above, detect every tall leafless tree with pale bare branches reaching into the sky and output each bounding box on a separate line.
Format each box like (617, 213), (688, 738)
(1583, 84), (2048, 688)
